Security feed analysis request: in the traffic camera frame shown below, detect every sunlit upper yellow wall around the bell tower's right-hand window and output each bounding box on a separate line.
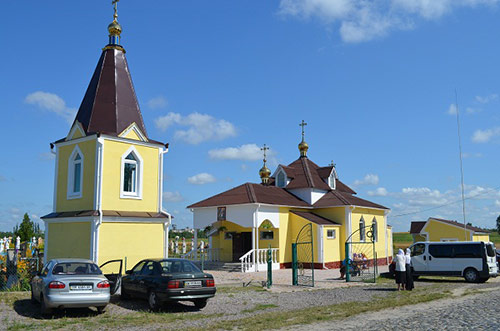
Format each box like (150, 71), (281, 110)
(102, 139), (159, 212)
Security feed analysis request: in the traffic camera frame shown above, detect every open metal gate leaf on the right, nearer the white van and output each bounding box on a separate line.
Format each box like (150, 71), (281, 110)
(343, 225), (378, 283)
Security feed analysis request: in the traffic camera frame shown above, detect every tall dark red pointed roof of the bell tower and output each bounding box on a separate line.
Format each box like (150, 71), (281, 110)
(75, 48), (147, 137)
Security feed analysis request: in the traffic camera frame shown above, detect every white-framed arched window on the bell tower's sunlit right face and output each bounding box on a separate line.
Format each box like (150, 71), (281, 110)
(120, 147), (142, 199)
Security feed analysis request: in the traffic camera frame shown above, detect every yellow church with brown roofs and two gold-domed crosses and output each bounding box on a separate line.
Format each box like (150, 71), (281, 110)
(187, 122), (393, 272)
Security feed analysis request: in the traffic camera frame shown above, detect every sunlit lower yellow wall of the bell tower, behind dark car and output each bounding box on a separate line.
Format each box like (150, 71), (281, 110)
(98, 222), (164, 269)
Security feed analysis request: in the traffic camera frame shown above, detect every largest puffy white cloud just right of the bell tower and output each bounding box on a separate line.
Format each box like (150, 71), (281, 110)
(155, 113), (236, 145)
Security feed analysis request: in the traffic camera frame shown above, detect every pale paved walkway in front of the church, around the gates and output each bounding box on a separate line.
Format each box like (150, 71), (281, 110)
(206, 266), (388, 288)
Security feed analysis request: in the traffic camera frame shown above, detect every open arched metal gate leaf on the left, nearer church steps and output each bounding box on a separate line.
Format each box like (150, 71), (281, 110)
(292, 223), (314, 287)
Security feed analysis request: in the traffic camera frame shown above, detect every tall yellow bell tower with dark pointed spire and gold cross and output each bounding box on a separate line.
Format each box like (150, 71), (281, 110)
(42, 2), (171, 267)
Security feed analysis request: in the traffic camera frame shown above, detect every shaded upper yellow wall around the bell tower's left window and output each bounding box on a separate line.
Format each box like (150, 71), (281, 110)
(56, 140), (96, 212)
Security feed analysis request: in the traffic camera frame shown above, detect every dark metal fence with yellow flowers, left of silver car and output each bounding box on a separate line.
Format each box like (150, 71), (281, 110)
(0, 249), (43, 291)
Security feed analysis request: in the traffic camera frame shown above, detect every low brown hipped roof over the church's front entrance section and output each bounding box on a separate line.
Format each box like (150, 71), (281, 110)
(187, 183), (311, 208)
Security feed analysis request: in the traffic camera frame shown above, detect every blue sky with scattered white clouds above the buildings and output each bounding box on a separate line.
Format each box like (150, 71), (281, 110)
(0, 0), (500, 231)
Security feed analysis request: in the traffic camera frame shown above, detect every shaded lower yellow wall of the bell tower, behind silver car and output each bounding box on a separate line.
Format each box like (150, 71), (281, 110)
(45, 222), (91, 261)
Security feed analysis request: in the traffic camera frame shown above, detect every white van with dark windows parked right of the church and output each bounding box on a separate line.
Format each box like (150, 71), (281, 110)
(410, 241), (498, 283)
